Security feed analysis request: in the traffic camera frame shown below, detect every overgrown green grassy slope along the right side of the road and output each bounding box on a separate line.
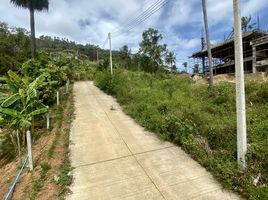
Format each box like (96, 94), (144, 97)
(95, 70), (268, 200)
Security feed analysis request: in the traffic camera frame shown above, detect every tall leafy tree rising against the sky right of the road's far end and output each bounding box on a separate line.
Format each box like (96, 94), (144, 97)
(139, 28), (167, 65)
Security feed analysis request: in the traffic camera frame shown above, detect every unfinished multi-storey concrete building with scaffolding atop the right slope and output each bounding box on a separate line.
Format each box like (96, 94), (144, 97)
(192, 30), (268, 74)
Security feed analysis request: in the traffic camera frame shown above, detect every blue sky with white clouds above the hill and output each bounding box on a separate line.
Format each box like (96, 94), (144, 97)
(0, 0), (268, 70)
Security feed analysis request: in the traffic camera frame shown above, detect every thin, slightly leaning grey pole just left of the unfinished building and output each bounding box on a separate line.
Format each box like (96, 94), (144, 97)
(202, 0), (213, 87)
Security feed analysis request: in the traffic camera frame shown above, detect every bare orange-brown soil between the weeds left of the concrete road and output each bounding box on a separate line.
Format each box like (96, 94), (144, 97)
(0, 94), (71, 200)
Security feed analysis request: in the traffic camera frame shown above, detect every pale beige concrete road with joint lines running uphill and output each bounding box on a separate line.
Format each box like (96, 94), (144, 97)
(66, 82), (239, 200)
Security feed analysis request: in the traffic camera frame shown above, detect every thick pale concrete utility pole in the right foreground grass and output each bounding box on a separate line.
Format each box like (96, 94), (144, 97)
(233, 0), (247, 170)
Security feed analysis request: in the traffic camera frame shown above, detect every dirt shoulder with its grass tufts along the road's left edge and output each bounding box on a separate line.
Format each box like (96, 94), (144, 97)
(0, 91), (73, 200)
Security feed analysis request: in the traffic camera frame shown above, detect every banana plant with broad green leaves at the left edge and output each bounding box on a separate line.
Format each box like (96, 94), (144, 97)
(0, 71), (48, 159)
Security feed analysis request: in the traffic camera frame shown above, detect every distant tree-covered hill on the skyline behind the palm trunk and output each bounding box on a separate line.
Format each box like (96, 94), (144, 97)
(0, 22), (118, 74)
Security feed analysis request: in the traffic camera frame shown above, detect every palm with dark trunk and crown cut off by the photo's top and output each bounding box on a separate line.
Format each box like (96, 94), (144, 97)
(10, 0), (49, 58)
